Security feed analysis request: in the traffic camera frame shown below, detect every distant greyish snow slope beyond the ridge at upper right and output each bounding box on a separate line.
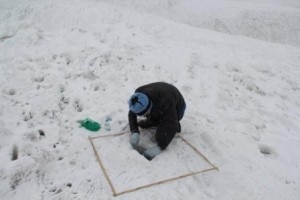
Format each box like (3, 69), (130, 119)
(99, 0), (300, 46)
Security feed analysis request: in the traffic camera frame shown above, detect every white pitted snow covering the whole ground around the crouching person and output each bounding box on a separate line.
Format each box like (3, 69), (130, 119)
(0, 0), (300, 200)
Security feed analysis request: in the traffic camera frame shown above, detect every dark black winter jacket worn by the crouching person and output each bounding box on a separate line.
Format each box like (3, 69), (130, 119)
(128, 82), (185, 149)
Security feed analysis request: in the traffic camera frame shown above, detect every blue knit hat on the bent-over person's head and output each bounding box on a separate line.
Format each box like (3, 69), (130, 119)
(128, 92), (152, 115)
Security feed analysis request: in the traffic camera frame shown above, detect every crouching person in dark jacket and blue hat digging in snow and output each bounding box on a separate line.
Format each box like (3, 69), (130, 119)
(128, 82), (186, 160)
